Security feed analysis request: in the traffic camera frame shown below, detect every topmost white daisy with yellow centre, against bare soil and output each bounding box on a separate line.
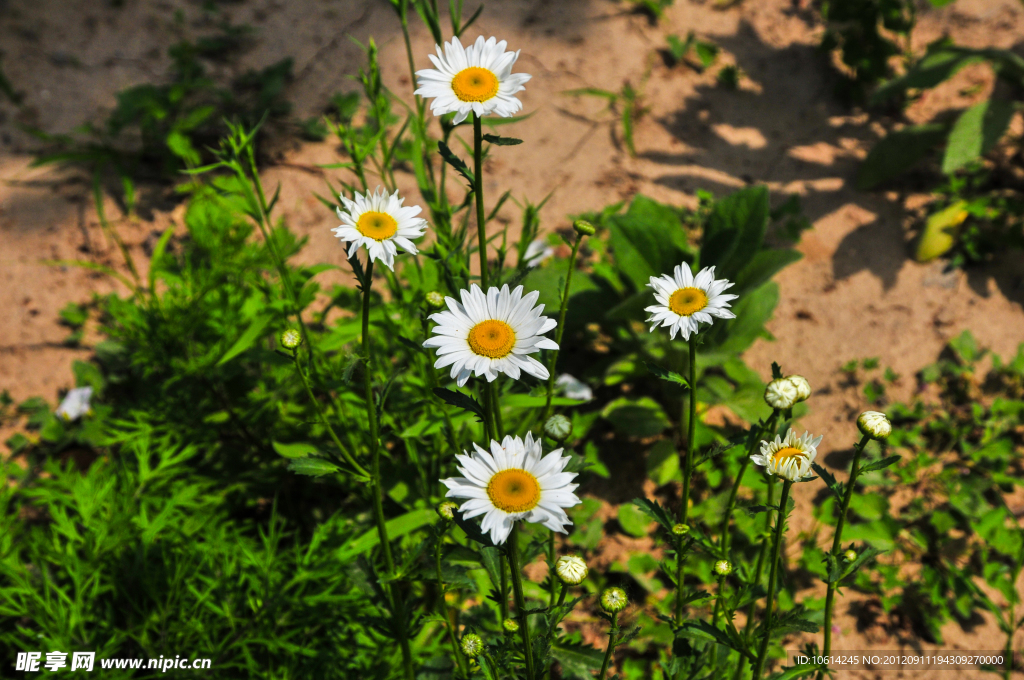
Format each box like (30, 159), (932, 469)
(415, 36), (531, 125)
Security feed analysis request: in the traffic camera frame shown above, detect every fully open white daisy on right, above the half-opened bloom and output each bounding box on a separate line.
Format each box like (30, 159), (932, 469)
(646, 262), (738, 340)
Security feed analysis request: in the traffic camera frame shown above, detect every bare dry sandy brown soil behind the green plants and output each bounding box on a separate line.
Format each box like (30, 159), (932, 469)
(0, 0), (1024, 678)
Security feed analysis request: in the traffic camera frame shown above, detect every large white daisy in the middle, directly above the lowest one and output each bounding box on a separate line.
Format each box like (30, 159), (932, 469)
(423, 284), (558, 387)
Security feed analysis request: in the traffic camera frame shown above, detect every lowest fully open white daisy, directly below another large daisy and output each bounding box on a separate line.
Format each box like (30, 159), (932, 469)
(441, 432), (580, 545)
